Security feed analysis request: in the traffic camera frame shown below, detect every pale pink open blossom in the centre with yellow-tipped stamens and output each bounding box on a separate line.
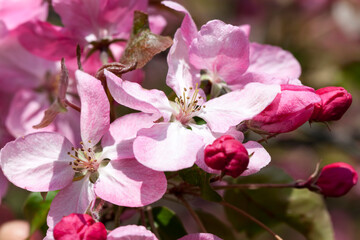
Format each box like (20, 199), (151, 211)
(105, 61), (279, 171)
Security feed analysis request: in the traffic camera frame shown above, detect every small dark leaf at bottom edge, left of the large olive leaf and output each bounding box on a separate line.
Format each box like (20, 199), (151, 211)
(196, 210), (236, 240)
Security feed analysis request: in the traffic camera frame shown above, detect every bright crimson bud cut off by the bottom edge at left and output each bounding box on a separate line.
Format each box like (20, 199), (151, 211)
(54, 213), (107, 240)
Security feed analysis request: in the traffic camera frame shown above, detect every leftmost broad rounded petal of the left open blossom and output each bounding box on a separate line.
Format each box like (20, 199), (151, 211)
(1, 132), (74, 192)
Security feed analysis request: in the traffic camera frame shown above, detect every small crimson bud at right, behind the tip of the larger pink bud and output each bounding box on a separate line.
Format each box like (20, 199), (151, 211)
(310, 87), (352, 122)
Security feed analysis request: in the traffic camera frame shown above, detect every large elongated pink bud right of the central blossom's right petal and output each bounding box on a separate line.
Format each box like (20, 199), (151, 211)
(246, 85), (321, 134)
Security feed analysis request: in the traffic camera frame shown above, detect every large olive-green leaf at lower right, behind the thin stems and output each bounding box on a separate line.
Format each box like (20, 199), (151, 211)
(224, 168), (334, 240)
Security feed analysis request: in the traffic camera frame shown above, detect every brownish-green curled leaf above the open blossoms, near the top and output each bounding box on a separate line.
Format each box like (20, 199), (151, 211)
(120, 11), (172, 68)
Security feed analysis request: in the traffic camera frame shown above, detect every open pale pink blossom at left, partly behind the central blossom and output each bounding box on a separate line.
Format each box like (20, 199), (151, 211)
(1, 71), (166, 228)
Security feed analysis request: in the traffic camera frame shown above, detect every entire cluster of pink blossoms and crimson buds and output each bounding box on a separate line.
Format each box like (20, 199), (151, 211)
(0, 0), (357, 240)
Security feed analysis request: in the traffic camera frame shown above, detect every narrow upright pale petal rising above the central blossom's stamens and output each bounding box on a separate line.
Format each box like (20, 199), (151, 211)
(166, 30), (200, 96)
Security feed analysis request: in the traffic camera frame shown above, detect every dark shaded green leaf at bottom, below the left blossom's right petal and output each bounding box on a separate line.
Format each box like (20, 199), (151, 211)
(152, 207), (187, 240)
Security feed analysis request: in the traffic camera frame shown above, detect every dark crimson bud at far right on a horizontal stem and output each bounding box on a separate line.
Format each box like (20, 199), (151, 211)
(312, 162), (358, 197)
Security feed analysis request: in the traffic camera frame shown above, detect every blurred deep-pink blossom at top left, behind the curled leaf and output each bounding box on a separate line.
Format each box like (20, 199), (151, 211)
(19, 0), (166, 73)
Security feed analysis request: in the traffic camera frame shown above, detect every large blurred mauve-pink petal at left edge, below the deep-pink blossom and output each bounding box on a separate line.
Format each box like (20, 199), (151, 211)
(0, 34), (58, 92)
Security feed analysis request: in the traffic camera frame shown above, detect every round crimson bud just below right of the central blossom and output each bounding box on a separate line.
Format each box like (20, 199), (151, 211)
(205, 135), (249, 178)
